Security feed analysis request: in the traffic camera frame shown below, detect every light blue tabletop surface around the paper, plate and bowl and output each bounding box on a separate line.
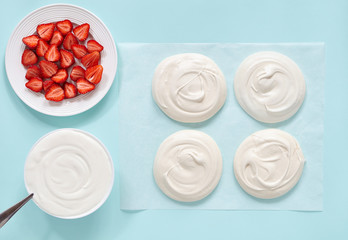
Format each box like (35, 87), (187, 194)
(0, 0), (348, 240)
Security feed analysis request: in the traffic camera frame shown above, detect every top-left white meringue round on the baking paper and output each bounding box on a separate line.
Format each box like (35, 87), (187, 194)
(152, 53), (227, 123)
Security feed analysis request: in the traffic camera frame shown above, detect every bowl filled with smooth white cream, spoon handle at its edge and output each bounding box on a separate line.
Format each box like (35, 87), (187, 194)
(24, 129), (114, 218)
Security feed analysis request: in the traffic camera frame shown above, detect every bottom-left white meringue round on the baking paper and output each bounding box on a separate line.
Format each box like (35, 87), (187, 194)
(153, 130), (222, 202)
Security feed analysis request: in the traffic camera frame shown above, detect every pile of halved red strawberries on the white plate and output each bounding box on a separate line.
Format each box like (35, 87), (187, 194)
(22, 19), (104, 102)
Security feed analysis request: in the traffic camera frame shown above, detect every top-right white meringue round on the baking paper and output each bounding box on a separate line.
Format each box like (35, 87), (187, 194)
(234, 52), (306, 123)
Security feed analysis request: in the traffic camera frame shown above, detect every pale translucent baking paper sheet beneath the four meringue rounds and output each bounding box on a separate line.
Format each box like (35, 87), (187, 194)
(115, 43), (325, 211)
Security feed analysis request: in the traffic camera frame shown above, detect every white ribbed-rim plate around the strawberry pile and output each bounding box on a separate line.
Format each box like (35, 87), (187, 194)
(5, 4), (117, 116)
